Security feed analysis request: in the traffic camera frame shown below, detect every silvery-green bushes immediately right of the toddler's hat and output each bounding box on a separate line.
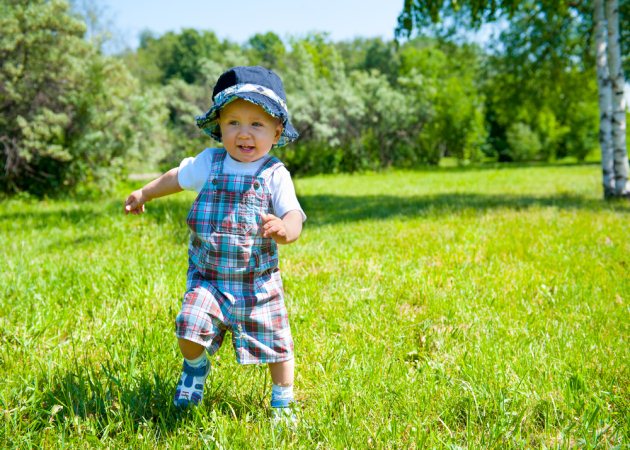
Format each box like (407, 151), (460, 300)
(278, 38), (432, 173)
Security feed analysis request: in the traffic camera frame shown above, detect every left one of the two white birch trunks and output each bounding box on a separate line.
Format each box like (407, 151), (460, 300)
(593, 0), (615, 198)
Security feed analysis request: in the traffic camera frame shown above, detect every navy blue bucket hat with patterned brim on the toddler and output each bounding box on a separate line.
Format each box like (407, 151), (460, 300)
(196, 66), (298, 147)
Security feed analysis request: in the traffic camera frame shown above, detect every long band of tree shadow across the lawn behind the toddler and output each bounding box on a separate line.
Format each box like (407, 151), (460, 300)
(0, 193), (630, 234)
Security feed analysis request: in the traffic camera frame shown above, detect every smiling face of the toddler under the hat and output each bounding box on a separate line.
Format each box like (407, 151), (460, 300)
(219, 99), (282, 162)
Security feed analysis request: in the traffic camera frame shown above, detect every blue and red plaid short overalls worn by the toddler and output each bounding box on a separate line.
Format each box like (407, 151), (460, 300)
(176, 150), (293, 364)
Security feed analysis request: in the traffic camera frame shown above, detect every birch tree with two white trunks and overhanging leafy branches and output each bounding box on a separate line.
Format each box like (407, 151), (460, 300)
(397, 0), (630, 198)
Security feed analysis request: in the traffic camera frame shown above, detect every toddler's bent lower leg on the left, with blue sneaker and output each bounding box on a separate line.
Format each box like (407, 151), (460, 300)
(173, 338), (210, 407)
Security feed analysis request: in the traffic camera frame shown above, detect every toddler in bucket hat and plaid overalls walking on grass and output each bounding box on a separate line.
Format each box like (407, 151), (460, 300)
(125, 66), (306, 419)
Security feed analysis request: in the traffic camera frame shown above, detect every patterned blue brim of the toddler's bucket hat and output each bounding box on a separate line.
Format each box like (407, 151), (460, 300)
(196, 92), (299, 147)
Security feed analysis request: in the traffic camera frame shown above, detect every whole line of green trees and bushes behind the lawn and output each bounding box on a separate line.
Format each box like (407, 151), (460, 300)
(0, 0), (612, 195)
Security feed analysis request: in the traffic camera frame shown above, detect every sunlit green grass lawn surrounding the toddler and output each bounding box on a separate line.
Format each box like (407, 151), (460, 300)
(0, 165), (630, 449)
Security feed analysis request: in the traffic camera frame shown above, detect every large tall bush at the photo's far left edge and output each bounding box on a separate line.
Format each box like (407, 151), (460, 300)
(0, 1), (91, 190)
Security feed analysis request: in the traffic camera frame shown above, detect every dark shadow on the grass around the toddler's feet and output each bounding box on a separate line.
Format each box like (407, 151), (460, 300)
(31, 361), (266, 439)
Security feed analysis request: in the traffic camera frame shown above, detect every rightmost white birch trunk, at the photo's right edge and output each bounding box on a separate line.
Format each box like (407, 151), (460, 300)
(606, 0), (628, 195)
